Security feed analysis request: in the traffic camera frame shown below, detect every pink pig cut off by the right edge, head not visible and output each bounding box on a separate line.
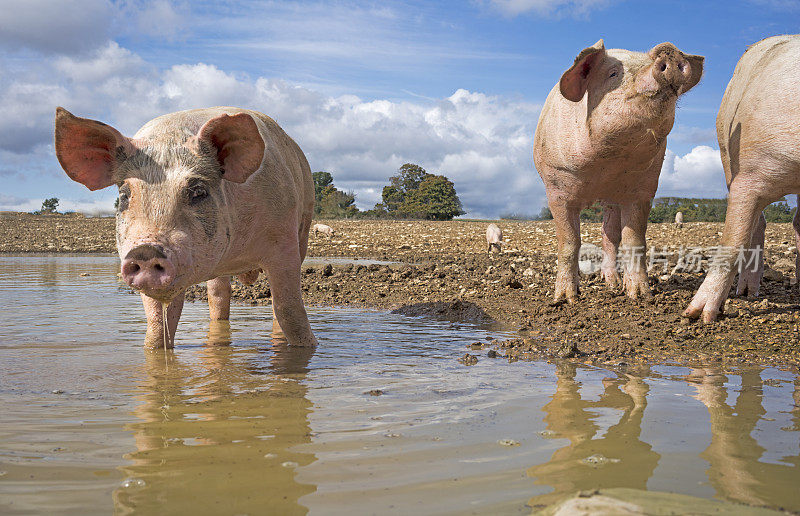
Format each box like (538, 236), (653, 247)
(684, 35), (800, 322)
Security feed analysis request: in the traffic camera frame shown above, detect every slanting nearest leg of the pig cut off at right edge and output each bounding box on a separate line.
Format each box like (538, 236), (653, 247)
(683, 183), (768, 322)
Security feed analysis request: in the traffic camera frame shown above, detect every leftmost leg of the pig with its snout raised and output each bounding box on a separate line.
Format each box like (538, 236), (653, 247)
(550, 203), (581, 303)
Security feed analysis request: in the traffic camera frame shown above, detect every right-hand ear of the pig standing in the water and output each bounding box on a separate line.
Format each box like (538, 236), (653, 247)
(197, 113), (265, 183)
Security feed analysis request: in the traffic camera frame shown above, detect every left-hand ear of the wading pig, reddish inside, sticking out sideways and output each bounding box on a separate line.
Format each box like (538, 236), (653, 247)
(56, 107), (135, 190)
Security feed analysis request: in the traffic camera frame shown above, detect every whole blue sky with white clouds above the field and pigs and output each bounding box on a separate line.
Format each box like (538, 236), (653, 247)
(0, 0), (800, 217)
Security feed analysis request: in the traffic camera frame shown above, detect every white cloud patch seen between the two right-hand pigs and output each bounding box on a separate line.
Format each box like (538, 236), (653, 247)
(656, 145), (728, 197)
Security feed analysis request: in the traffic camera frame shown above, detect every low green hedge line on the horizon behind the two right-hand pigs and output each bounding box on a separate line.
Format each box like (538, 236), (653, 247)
(510, 197), (797, 222)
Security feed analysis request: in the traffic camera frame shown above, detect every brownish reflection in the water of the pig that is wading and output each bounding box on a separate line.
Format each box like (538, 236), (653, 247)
(113, 336), (316, 514)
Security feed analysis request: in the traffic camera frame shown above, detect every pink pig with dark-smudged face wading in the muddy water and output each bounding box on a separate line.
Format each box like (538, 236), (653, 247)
(55, 107), (316, 347)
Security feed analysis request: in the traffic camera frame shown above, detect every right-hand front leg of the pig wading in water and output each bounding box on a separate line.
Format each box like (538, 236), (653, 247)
(262, 240), (317, 346)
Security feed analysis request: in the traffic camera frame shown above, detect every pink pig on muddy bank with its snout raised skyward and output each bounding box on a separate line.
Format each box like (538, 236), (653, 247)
(533, 40), (703, 302)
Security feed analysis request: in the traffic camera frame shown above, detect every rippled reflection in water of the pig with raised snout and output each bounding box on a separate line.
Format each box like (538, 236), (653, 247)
(527, 363), (661, 506)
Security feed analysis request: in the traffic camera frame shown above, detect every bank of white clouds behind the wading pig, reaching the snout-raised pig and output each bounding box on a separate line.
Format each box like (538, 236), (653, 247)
(0, 42), (544, 216)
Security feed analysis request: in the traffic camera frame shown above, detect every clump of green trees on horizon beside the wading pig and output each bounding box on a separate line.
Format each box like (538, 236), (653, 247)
(312, 163), (465, 220)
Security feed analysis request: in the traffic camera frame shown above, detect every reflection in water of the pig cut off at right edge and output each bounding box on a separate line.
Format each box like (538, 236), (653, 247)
(687, 368), (800, 509)
